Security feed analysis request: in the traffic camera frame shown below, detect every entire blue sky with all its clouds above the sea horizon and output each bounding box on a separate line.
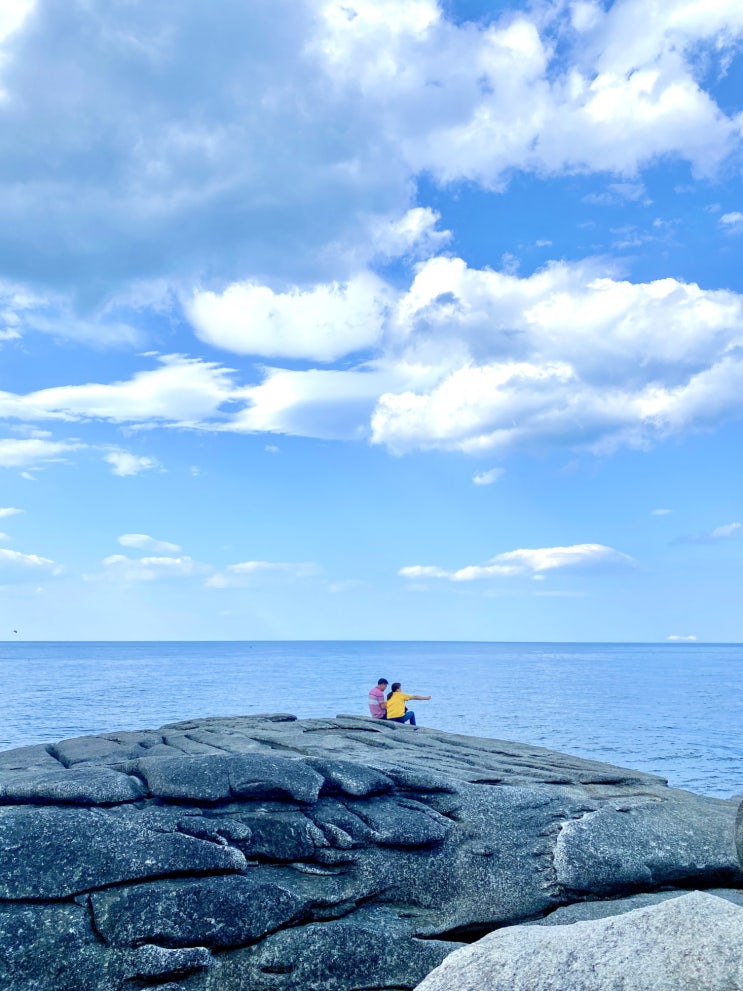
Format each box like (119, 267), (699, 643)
(0, 0), (743, 641)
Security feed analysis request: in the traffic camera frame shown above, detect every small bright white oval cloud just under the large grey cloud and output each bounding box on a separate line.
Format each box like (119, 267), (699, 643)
(187, 273), (390, 361)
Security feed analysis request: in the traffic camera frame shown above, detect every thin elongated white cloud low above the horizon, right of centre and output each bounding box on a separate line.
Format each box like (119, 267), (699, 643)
(398, 544), (635, 582)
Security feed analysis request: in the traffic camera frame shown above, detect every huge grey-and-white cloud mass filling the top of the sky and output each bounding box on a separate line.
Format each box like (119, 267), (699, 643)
(0, 0), (743, 314)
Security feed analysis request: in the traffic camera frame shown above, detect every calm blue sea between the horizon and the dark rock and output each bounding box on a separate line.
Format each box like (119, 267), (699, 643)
(0, 641), (743, 797)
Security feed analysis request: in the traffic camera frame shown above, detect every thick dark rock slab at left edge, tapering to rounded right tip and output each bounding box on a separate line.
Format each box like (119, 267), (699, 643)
(0, 807), (245, 900)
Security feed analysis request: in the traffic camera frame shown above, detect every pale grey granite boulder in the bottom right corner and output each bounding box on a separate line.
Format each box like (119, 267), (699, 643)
(418, 891), (743, 991)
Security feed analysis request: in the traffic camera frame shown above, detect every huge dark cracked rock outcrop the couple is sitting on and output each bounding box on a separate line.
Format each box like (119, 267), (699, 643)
(0, 714), (743, 991)
